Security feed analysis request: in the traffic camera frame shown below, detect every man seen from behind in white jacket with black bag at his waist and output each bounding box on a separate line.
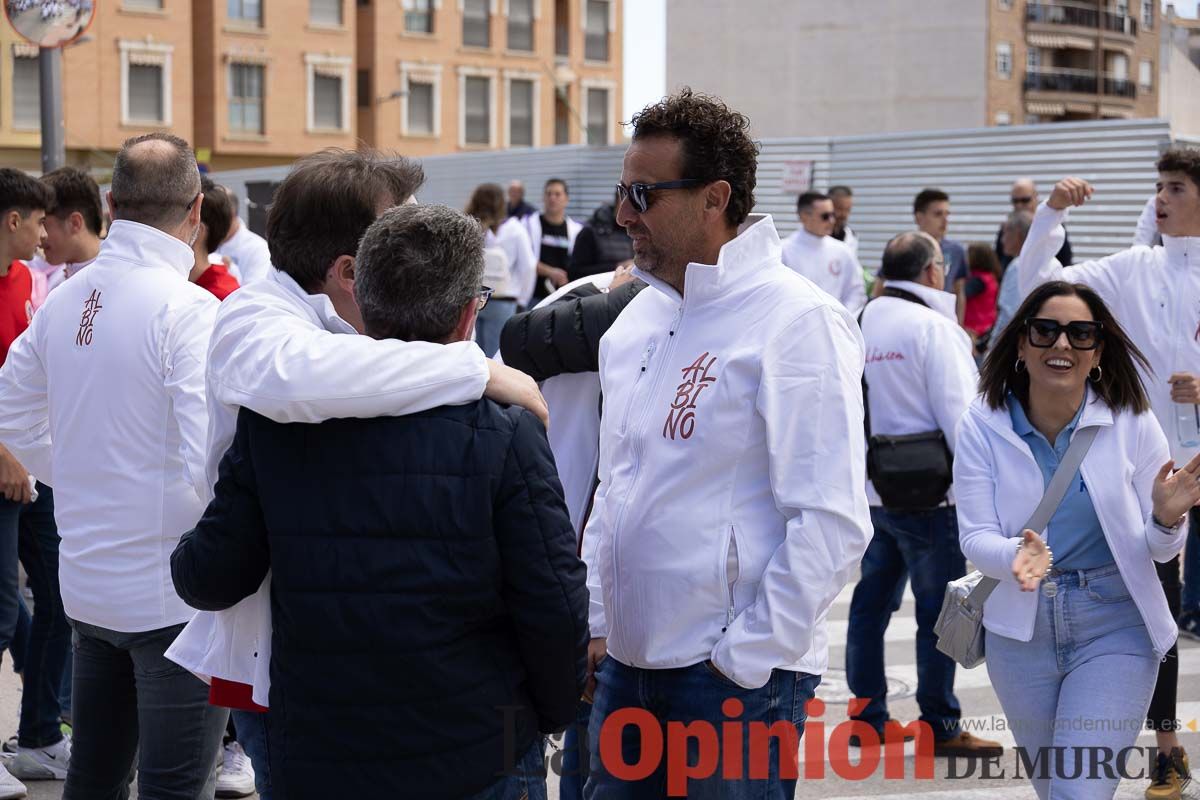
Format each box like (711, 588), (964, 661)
(846, 231), (1001, 756)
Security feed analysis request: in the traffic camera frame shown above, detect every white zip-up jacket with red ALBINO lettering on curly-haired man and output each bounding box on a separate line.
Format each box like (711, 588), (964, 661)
(583, 215), (871, 687)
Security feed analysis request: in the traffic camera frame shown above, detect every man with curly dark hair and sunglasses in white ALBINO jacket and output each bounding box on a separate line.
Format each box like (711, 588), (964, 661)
(584, 90), (870, 800)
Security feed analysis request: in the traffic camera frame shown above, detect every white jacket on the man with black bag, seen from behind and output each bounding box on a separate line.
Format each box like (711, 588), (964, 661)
(863, 281), (979, 505)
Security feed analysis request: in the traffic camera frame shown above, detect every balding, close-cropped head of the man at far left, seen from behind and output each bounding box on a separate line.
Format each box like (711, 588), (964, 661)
(112, 133), (200, 230)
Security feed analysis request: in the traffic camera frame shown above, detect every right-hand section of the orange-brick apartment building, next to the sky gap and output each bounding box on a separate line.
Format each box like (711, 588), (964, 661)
(356, 0), (623, 156)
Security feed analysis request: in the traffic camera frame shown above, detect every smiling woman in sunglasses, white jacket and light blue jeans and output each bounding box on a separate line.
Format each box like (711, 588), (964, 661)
(954, 281), (1200, 800)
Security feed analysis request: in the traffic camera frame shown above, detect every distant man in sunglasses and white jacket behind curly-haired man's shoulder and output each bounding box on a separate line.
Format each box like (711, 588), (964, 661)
(784, 192), (866, 314)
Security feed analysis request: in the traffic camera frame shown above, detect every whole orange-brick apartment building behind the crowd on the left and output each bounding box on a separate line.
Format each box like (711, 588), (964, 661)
(7, 0), (623, 172)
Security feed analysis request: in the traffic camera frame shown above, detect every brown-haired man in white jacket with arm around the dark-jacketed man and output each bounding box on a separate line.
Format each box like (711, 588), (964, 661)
(171, 150), (546, 794)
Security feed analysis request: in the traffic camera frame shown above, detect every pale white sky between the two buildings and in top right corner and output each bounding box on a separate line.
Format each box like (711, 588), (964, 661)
(620, 0), (1200, 130)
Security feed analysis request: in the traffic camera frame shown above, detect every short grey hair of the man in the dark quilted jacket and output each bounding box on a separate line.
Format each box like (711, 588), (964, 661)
(354, 205), (484, 342)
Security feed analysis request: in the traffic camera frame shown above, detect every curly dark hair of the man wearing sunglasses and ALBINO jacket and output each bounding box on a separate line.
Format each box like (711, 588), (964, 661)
(631, 88), (758, 227)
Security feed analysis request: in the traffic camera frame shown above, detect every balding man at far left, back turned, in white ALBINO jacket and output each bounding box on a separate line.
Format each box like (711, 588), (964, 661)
(0, 133), (227, 800)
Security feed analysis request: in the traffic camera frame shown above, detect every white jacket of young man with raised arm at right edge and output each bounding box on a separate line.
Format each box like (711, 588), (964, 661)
(1018, 203), (1200, 465)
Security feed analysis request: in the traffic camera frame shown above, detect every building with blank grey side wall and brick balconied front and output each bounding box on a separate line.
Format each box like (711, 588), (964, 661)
(667, 0), (1159, 137)
